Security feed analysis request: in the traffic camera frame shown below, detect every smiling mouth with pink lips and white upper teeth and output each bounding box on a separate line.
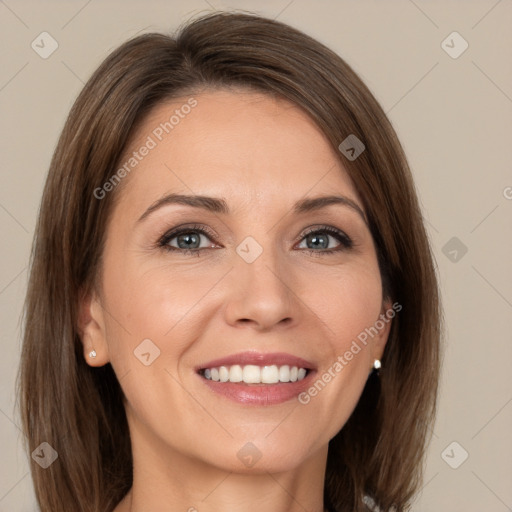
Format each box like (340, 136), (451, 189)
(196, 352), (316, 406)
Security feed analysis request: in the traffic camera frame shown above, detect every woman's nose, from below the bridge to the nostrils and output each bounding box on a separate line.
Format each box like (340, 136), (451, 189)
(224, 244), (299, 331)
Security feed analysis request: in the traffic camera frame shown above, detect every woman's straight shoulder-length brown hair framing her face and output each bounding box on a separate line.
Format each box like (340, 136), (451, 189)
(19, 12), (441, 512)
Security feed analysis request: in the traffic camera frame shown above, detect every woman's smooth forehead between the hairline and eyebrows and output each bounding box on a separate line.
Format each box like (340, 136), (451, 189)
(114, 90), (357, 214)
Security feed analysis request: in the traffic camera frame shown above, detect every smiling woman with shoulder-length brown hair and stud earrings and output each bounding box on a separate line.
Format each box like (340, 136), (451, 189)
(20, 13), (440, 512)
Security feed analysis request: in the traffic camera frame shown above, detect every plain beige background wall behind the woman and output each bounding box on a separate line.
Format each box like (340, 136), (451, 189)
(0, 0), (512, 512)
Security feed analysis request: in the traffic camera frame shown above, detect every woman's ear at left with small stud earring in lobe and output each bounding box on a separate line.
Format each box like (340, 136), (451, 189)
(78, 291), (109, 366)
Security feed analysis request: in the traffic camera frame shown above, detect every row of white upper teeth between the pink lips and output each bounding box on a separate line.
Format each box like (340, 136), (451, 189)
(203, 364), (306, 384)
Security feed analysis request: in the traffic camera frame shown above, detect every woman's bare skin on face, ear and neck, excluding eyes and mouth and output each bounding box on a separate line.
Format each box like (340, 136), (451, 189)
(81, 90), (391, 512)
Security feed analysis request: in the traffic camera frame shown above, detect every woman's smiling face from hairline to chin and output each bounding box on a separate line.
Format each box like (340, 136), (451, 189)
(83, 90), (390, 472)
